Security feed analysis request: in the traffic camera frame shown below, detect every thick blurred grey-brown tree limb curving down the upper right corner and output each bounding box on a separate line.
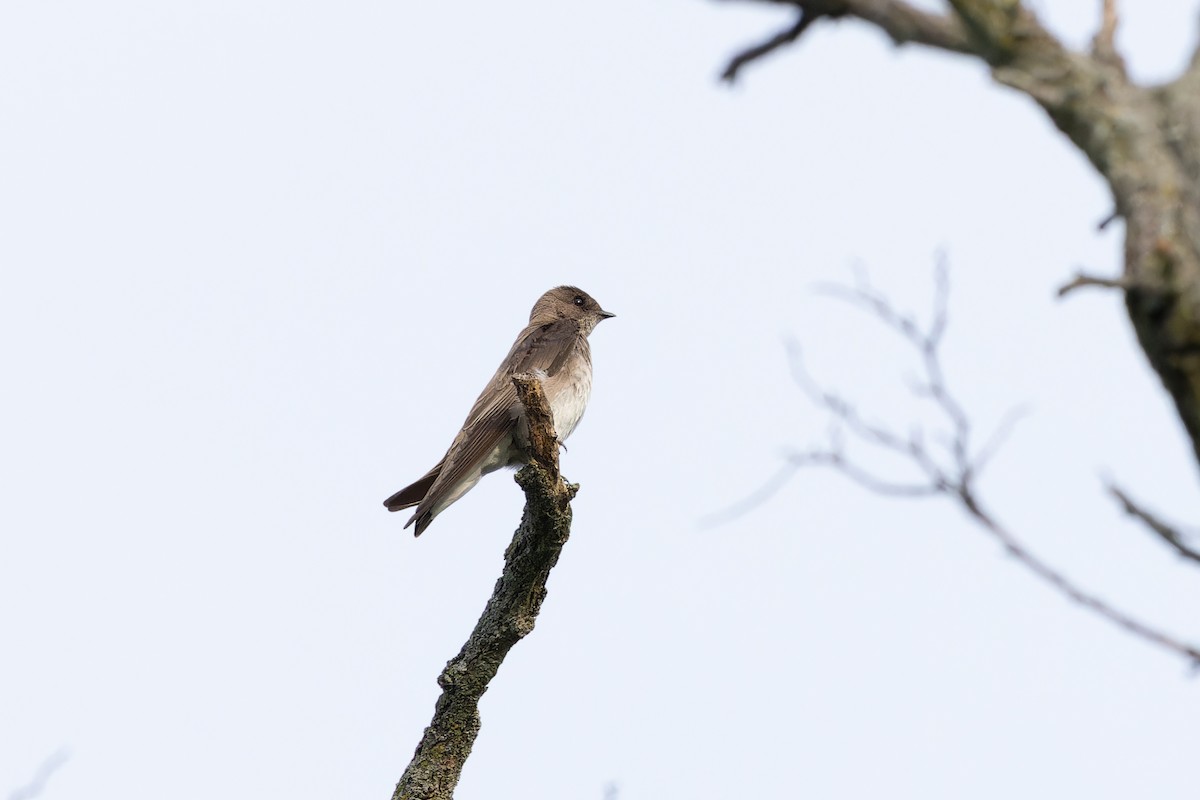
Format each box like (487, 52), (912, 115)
(727, 0), (1200, 472)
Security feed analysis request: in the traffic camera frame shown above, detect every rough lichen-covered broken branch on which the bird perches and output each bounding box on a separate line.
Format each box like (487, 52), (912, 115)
(391, 375), (578, 800)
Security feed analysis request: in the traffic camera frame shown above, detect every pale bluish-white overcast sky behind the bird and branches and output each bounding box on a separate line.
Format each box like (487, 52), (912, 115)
(0, 0), (1200, 800)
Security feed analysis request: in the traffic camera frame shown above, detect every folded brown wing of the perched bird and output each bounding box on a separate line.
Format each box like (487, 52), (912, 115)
(403, 319), (580, 536)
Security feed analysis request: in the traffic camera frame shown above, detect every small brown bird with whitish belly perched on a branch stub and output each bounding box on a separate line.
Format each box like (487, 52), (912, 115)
(383, 287), (616, 536)
